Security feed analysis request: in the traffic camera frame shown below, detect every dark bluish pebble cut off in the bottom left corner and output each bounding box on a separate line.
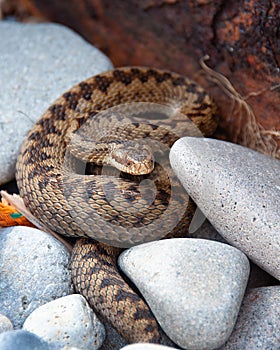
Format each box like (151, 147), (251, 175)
(0, 330), (52, 350)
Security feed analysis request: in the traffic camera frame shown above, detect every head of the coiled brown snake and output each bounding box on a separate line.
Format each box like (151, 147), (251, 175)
(106, 141), (154, 175)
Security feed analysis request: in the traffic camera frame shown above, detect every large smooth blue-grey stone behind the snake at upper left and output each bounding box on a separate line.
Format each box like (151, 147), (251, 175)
(0, 21), (112, 185)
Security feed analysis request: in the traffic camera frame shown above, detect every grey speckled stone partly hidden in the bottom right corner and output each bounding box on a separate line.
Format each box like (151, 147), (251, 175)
(220, 286), (280, 350)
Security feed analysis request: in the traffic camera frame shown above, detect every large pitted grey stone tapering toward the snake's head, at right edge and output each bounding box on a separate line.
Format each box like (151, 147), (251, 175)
(170, 137), (280, 279)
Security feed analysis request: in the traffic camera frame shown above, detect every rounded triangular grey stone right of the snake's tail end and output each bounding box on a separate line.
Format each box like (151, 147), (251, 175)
(119, 238), (249, 350)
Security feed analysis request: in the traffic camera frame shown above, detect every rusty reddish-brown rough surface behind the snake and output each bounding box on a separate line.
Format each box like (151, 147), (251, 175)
(2, 0), (280, 158)
